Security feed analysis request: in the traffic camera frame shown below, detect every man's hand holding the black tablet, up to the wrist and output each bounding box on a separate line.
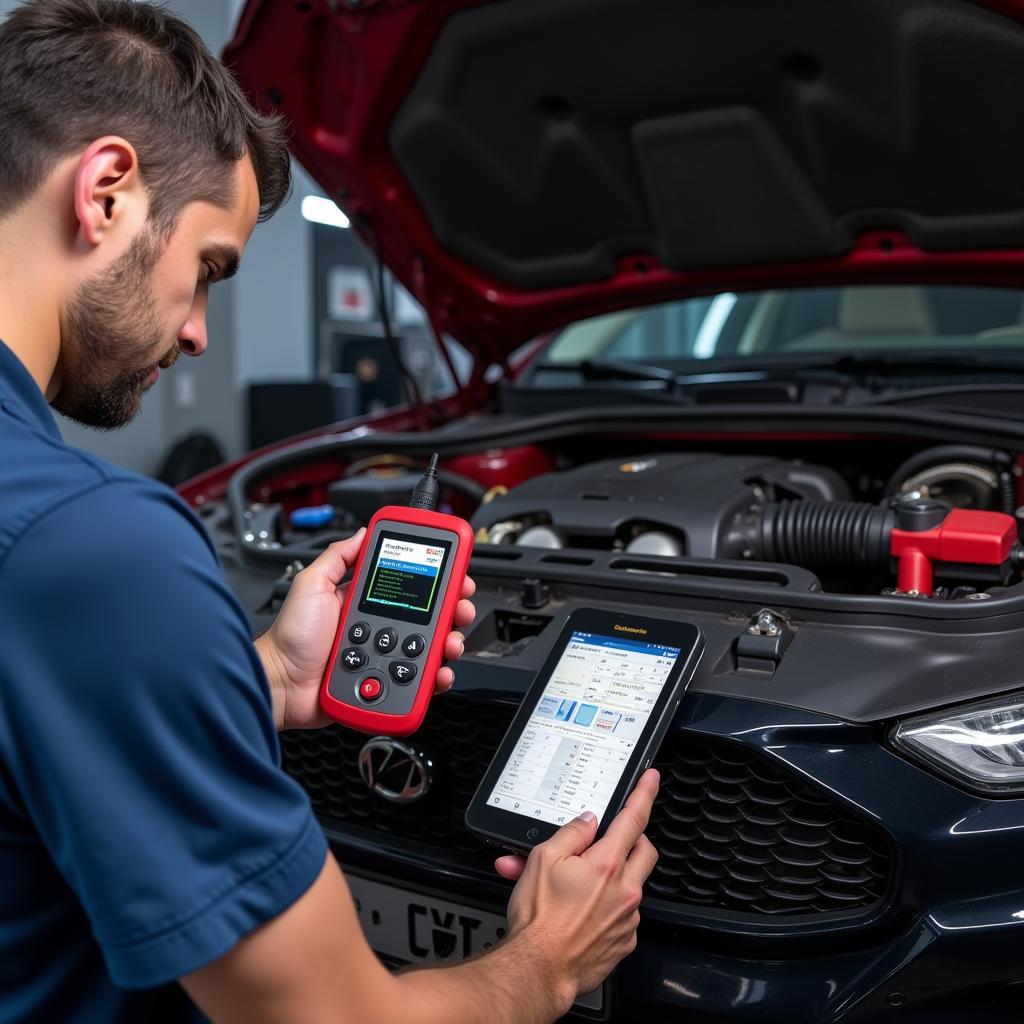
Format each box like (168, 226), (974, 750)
(495, 768), (658, 1012)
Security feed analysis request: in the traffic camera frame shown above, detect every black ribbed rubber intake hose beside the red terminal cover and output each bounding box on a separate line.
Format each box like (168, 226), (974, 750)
(761, 501), (896, 568)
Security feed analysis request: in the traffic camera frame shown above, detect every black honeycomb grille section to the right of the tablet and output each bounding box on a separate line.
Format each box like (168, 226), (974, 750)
(647, 733), (893, 916)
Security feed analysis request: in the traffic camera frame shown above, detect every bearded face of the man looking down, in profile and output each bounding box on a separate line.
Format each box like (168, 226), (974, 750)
(52, 159), (259, 430)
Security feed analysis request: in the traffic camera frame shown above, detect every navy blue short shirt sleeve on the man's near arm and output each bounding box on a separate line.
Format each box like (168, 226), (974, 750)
(0, 478), (327, 988)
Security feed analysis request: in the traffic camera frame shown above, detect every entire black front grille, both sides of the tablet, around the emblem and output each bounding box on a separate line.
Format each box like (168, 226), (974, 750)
(282, 695), (893, 918)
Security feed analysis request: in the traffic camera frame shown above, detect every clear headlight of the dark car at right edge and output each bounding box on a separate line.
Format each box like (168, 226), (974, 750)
(892, 693), (1024, 796)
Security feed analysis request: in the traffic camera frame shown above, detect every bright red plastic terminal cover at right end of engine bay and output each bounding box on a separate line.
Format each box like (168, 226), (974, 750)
(891, 509), (1017, 595)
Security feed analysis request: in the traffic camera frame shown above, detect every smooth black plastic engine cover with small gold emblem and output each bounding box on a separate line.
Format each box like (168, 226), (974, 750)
(473, 454), (850, 558)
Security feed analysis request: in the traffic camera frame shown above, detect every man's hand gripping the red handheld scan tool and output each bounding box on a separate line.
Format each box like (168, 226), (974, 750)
(256, 529), (476, 730)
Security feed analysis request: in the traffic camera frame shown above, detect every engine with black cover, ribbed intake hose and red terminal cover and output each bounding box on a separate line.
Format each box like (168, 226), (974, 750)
(473, 455), (1024, 598)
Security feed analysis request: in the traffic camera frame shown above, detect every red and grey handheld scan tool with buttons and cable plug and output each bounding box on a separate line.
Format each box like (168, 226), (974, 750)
(321, 456), (473, 736)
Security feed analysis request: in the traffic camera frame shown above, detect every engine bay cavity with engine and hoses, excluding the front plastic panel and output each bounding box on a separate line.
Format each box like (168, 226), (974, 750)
(205, 438), (1024, 601)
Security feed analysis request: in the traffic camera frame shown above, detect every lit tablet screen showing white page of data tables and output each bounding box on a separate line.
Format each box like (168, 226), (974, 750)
(487, 631), (680, 825)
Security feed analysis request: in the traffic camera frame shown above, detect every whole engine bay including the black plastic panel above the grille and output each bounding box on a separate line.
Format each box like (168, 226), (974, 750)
(186, 408), (1024, 725)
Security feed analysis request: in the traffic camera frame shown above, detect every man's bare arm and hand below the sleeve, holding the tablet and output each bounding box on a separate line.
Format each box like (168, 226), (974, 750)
(181, 771), (657, 1024)
